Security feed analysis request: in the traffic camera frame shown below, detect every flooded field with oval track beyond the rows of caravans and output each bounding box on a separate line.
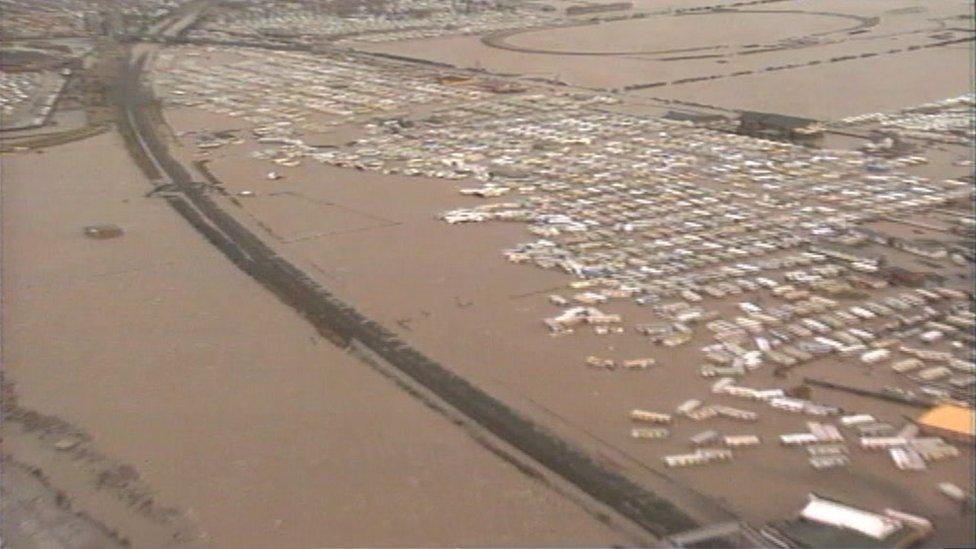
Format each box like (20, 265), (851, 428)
(357, 0), (973, 120)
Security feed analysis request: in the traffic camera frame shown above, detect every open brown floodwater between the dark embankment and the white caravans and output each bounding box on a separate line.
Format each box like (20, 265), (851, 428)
(185, 107), (973, 544)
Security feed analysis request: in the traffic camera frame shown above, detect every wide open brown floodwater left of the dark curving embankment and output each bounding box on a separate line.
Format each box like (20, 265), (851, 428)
(3, 134), (623, 547)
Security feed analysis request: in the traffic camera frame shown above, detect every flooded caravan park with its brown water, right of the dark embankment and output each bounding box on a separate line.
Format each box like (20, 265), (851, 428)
(155, 31), (976, 539)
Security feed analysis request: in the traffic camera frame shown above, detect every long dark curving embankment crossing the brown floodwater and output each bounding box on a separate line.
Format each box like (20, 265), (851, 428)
(118, 37), (712, 537)
